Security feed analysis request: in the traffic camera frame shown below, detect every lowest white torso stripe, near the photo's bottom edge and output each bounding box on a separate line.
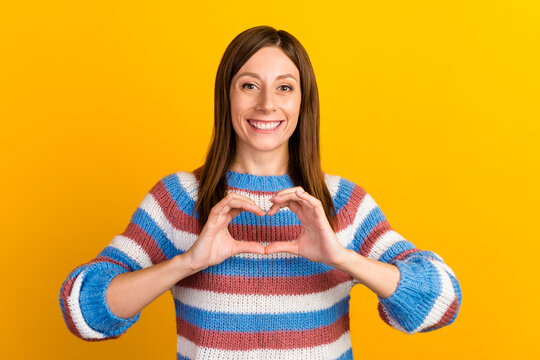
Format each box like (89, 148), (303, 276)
(176, 331), (352, 360)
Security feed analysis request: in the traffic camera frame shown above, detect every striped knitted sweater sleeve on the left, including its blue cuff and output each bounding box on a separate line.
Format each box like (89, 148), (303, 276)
(58, 175), (181, 341)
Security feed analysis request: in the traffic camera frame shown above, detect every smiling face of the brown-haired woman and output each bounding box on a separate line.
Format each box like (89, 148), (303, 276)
(230, 46), (301, 151)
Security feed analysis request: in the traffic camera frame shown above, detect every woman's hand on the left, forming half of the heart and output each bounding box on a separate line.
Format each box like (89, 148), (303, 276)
(184, 192), (266, 271)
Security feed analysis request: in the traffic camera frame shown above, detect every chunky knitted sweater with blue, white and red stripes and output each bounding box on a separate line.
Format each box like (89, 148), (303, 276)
(59, 170), (462, 360)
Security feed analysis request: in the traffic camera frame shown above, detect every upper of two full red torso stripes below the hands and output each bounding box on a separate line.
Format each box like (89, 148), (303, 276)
(176, 269), (353, 295)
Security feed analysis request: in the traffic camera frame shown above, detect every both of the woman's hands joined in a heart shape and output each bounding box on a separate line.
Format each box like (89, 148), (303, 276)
(185, 187), (346, 271)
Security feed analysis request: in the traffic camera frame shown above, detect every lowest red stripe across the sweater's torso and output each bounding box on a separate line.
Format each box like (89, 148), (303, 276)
(176, 313), (349, 350)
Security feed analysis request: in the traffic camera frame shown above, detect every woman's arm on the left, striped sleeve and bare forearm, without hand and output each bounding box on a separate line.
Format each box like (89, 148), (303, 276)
(59, 173), (192, 341)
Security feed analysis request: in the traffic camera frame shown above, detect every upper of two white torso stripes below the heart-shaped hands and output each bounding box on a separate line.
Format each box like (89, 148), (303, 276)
(171, 281), (352, 314)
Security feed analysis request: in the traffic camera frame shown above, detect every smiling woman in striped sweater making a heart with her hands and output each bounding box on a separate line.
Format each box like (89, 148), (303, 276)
(59, 26), (461, 359)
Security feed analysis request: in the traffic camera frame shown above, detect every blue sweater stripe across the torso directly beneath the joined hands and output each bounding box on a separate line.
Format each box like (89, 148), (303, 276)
(201, 256), (334, 277)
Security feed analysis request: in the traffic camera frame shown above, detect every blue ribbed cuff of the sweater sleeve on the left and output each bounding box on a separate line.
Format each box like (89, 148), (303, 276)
(79, 263), (141, 336)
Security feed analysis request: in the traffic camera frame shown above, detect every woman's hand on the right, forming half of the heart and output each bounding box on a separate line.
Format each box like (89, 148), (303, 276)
(266, 186), (347, 266)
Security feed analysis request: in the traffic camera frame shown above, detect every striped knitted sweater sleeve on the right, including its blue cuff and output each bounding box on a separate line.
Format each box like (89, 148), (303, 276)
(341, 179), (462, 334)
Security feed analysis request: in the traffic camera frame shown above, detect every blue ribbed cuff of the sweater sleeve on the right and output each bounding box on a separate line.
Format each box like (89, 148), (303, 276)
(377, 257), (441, 331)
